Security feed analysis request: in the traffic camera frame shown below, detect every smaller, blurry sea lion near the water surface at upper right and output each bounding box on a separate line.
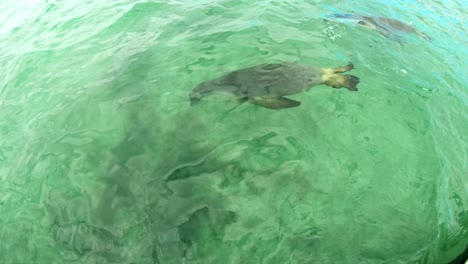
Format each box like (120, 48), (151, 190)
(328, 13), (432, 42)
